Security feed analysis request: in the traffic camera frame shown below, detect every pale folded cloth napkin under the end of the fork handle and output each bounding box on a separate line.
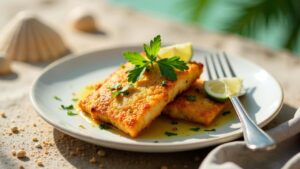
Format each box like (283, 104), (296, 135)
(199, 108), (300, 169)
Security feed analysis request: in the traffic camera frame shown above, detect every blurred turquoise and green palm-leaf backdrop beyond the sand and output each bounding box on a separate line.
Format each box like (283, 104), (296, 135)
(109, 0), (300, 56)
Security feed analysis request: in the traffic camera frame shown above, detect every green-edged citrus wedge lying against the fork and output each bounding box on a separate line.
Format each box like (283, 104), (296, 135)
(204, 78), (243, 101)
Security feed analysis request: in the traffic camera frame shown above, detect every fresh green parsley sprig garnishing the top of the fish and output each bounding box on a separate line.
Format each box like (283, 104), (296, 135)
(123, 35), (188, 83)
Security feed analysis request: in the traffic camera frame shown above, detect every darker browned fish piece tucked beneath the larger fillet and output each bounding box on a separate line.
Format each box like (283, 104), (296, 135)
(163, 79), (226, 125)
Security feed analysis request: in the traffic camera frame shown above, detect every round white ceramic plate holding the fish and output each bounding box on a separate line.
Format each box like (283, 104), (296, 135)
(31, 46), (283, 152)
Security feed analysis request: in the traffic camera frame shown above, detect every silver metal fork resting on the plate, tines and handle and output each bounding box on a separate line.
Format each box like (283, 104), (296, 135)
(204, 53), (276, 150)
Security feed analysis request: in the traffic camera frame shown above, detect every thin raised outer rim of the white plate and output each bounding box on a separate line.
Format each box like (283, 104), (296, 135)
(30, 45), (284, 152)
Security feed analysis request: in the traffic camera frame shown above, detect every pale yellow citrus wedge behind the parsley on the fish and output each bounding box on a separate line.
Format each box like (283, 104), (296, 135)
(158, 42), (193, 63)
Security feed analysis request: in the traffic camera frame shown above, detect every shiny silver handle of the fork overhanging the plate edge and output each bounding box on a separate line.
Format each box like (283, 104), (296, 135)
(229, 96), (276, 150)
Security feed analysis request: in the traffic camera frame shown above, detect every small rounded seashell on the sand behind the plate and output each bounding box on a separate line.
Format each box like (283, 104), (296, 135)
(69, 7), (98, 32)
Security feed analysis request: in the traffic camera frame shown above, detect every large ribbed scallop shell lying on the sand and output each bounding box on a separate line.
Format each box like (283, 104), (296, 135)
(0, 11), (69, 62)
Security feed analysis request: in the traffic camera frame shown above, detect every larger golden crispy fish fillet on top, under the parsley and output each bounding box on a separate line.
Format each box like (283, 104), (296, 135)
(79, 62), (203, 137)
